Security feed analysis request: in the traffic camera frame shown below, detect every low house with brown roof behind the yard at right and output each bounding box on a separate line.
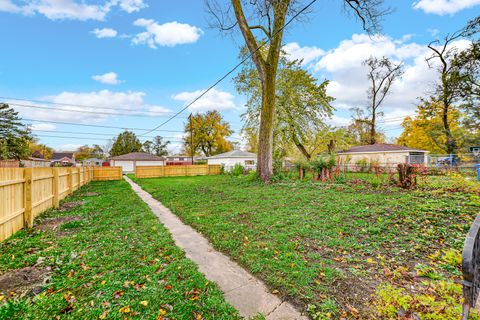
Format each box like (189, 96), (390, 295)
(338, 143), (428, 166)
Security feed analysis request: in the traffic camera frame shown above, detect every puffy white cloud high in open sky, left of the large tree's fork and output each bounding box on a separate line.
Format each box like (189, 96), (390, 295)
(132, 19), (203, 49)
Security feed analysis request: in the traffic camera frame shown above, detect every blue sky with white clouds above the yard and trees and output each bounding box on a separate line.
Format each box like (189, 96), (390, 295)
(0, 0), (480, 152)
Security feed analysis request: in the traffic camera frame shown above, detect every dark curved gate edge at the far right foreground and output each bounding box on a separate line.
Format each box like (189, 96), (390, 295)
(462, 215), (480, 320)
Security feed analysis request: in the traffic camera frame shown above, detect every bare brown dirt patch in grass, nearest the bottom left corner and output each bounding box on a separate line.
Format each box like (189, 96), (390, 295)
(0, 266), (50, 295)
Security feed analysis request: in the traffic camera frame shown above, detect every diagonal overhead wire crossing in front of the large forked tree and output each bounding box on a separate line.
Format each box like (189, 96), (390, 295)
(140, 0), (317, 136)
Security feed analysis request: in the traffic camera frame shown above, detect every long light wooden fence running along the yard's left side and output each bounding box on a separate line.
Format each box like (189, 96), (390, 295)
(0, 167), (122, 241)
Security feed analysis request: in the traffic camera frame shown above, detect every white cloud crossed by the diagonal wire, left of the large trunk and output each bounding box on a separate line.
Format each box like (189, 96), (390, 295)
(172, 88), (236, 112)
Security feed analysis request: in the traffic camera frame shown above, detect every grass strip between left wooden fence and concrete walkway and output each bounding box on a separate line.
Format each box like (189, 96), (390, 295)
(0, 181), (239, 319)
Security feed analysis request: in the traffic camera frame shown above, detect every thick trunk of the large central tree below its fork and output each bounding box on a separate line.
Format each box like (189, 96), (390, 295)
(257, 70), (276, 182)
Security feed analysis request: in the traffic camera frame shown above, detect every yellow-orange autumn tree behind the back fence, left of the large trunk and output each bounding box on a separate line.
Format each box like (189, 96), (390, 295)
(184, 111), (233, 157)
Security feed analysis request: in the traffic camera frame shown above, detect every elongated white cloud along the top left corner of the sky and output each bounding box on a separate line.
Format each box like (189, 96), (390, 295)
(0, 0), (147, 21)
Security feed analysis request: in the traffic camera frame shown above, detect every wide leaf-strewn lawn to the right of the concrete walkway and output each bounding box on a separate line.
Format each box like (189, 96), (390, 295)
(132, 175), (480, 319)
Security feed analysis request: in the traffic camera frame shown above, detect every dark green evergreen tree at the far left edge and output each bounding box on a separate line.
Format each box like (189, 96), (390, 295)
(0, 103), (32, 160)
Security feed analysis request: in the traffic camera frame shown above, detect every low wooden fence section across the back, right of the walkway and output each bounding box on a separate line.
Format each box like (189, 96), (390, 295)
(135, 165), (221, 178)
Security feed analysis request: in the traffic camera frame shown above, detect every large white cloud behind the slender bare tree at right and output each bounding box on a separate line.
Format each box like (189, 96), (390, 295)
(300, 34), (470, 131)
